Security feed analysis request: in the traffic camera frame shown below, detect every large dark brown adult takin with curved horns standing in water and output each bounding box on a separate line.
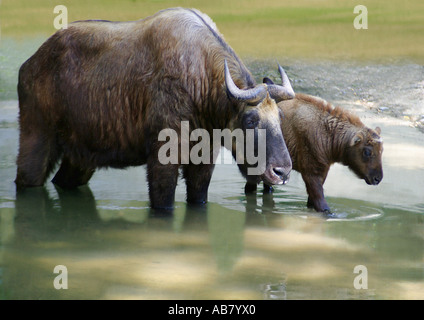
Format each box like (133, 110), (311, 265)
(15, 8), (294, 208)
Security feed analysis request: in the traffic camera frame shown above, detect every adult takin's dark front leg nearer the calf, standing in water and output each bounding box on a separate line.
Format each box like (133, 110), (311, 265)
(183, 164), (215, 204)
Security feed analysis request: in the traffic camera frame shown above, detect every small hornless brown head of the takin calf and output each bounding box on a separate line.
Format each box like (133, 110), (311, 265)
(344, 127), (383, 185)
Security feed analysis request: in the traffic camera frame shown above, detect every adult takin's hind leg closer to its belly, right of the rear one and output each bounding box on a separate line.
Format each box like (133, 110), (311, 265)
(52, 157), (95, 189)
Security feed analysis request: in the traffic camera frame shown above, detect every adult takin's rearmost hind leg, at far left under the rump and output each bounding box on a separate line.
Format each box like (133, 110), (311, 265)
(15, 131), (59, 189)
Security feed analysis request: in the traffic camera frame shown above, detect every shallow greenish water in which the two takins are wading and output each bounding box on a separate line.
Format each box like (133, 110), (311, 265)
(0, 38), (424, 299)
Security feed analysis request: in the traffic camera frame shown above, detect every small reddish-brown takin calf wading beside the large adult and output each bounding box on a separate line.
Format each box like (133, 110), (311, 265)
(245, 92), (383, 212)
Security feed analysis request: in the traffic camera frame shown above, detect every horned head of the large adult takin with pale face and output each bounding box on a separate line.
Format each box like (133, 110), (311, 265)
(225, 62), (294, 185)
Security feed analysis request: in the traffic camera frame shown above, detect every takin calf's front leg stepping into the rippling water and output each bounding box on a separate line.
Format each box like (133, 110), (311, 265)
(302, 173), (330, 212)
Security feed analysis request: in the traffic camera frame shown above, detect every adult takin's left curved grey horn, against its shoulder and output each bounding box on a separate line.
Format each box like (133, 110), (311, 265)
(224, 60), (267, 104)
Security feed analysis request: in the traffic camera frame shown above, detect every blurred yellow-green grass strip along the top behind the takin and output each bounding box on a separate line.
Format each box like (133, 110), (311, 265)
(0, 0), (424, 62)
